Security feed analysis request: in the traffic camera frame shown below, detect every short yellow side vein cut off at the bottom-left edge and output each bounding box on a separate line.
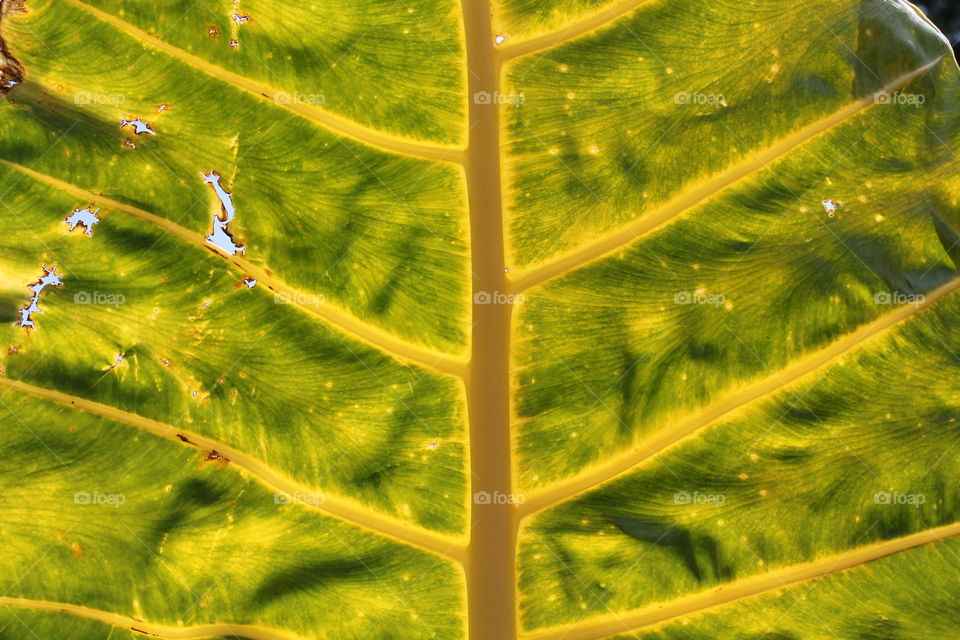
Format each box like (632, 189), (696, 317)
(0, 596), (306, 640)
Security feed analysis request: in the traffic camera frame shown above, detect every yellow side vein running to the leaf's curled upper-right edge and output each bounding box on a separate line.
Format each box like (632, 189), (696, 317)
(512, 56), (942, 292)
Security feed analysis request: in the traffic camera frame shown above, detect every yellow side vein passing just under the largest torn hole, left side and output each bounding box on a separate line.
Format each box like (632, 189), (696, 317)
(0, 159), (466, 377)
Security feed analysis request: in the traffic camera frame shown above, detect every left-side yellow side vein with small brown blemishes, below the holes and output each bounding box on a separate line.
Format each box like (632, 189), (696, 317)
(0, 377), (465, 562)
